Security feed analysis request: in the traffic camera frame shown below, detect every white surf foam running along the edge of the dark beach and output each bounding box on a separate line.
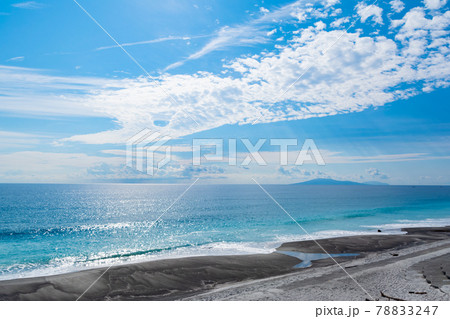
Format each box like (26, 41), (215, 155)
(0, 218), (450, 280)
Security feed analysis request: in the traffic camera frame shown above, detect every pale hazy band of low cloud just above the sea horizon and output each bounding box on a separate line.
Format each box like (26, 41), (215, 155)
(0, 146), (450, 183)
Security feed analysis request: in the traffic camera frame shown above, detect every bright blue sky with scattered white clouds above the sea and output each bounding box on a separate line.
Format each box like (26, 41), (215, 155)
(0, 0), (450, 185)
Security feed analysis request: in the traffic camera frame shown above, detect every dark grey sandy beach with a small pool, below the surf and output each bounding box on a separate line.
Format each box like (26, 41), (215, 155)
(0, 227), (450, 300)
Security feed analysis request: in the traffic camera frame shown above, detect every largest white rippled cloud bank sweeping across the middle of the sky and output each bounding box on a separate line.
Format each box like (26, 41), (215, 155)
(0, 3), (450, 150)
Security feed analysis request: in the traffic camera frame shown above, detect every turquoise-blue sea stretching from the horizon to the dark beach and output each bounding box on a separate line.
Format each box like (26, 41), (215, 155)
(0, 184), (450, 279)
